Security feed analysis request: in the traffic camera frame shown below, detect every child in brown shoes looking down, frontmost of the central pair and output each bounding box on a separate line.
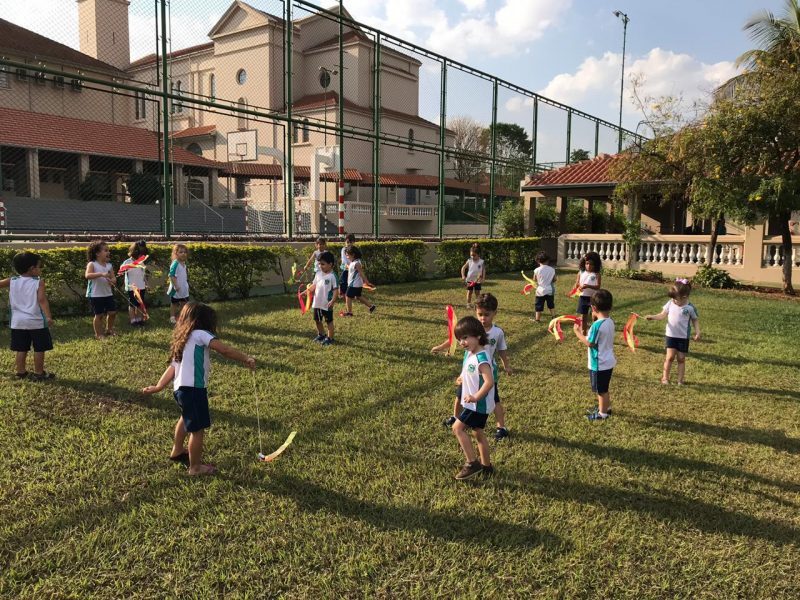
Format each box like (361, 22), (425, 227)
(453, 317), (495, 481)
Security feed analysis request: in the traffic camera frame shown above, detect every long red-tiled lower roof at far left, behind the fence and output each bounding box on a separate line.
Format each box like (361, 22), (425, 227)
(0, 107), (222, 168)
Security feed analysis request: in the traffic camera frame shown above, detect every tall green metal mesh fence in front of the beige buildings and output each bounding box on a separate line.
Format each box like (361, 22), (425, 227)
(0, 0), (636, 239)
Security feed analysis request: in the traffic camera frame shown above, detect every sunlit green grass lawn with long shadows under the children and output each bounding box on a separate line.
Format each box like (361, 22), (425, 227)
(0, 275), (800, 598)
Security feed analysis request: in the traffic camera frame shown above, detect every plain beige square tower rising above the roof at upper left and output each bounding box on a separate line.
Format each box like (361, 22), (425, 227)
(77, 0), (131, 71)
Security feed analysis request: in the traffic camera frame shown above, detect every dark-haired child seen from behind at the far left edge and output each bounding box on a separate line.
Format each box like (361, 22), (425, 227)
(0, 252), (55, 381)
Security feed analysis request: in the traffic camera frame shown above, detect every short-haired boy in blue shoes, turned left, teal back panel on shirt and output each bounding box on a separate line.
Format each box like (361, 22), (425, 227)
(573, 289), (617, 421)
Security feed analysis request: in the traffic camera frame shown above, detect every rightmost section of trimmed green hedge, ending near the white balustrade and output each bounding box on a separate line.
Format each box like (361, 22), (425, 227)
(436, 238), (541, 277)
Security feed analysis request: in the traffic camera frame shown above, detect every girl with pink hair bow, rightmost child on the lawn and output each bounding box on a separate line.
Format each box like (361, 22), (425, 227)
(645, 279), (700, 385)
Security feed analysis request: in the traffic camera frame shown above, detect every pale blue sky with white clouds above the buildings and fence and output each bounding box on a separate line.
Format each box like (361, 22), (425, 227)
(0, 0), (782, 160)
